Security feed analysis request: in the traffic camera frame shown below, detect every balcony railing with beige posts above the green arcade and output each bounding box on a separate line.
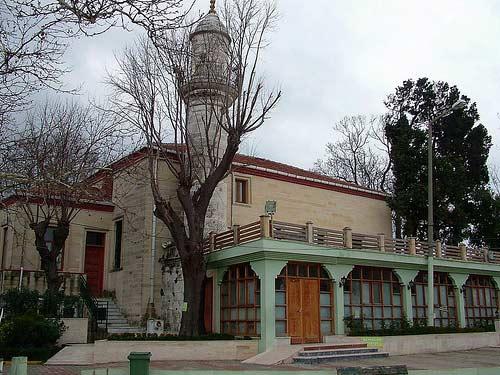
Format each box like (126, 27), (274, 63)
(204, 215), (500, 264)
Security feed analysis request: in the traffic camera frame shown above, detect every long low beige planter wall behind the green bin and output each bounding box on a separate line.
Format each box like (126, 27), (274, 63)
(94, 340), (258, 364)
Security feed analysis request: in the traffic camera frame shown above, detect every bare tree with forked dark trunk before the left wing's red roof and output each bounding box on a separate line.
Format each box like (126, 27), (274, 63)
(3, 102), (118, 292)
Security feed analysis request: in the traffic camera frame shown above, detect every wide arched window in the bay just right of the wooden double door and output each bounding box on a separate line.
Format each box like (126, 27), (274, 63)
(344, 266), (403, 330)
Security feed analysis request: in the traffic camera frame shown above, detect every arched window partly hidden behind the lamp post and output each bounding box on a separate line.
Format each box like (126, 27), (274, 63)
(411, 271), (458, 327)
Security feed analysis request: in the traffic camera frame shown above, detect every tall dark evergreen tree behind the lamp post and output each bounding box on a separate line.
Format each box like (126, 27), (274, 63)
(385, 78), (498, 243)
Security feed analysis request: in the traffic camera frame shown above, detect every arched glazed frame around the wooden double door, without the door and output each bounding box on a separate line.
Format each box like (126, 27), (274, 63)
(276, 263), (334, 336)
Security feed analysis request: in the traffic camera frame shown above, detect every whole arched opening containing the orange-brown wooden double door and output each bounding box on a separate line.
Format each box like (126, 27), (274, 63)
(276, 263), (334, 344)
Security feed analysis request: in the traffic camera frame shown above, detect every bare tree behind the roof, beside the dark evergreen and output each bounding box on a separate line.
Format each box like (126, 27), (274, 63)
(314, 115), (391, 191)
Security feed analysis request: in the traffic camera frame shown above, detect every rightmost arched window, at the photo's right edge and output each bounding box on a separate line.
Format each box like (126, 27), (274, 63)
(464, 275), (497, 327)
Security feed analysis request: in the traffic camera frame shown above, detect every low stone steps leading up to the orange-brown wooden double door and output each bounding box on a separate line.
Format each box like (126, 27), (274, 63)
(293, 343), (389, 364)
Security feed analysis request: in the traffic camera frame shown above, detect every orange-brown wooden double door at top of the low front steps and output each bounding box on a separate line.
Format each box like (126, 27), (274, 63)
(286, 278), (321, 344)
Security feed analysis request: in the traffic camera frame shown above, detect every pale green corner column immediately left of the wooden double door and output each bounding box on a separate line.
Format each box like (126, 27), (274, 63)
(250, 259), (287, 353)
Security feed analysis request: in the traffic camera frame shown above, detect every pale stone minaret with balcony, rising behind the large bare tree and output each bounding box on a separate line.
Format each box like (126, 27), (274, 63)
(182, 0), (236, 234)
